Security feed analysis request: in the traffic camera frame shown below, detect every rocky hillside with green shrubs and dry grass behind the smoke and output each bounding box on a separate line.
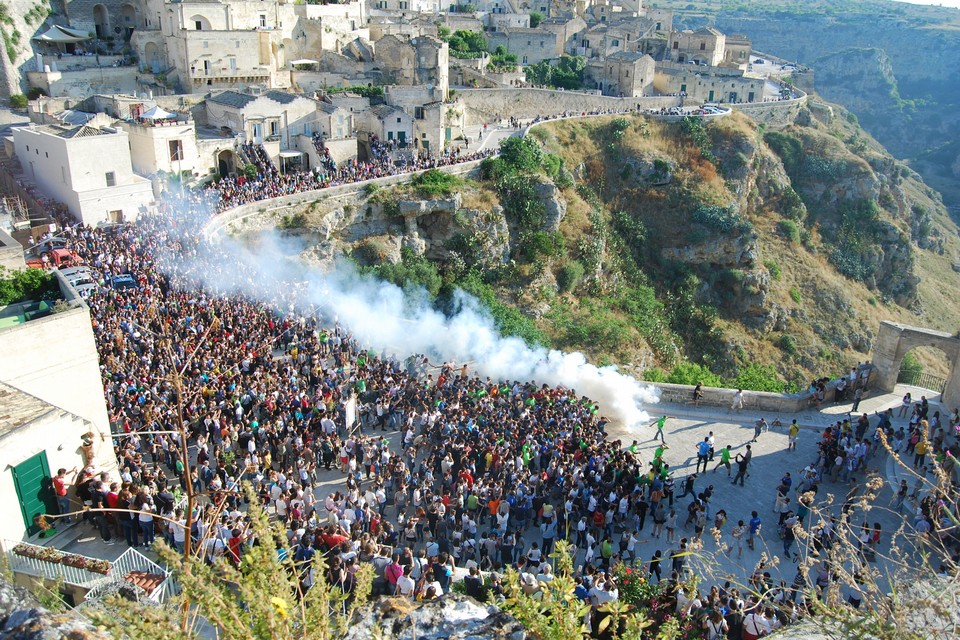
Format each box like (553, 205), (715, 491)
(304, 101), (960, 391)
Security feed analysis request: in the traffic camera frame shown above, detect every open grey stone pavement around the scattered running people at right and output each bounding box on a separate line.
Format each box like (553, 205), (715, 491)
(608, 385), (950, 588)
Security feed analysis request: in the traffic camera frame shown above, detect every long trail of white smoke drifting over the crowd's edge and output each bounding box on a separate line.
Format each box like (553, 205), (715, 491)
(187, 224), (659, 428)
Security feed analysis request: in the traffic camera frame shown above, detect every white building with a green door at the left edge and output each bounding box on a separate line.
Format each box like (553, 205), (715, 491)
(0, 271), (117, 540)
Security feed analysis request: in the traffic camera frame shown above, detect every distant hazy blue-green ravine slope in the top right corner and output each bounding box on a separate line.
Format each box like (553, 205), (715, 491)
(674, 3), (960, 207)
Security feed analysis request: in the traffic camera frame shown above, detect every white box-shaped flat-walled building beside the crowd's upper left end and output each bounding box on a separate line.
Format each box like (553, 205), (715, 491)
(13, 125), (153, 224)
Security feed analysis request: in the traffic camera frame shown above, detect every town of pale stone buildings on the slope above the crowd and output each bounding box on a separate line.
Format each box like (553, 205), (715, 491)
(4, 0), (801, 228)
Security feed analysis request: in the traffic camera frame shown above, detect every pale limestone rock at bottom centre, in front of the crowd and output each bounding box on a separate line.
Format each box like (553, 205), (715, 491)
(345, 593), (527, 640)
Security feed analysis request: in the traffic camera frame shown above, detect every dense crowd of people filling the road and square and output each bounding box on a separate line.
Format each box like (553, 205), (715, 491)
(37, 144), (960, 638)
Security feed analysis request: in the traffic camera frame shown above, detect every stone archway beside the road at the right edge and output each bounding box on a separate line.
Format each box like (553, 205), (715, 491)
(873, 321), (960, 407)
